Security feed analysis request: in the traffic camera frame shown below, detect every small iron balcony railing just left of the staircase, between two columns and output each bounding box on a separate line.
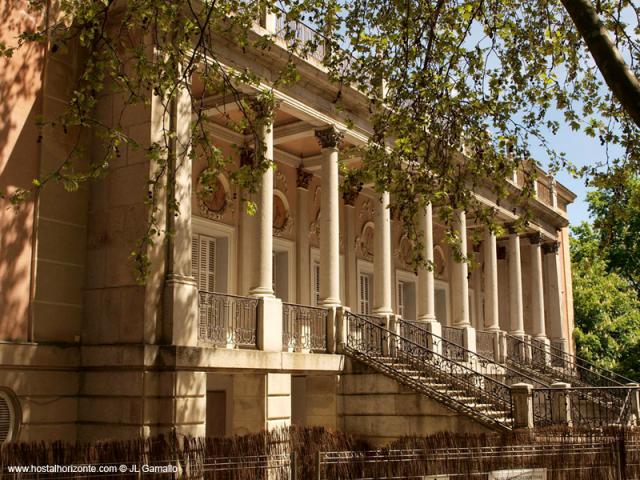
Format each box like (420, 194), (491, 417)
(282, 303), (329, 352)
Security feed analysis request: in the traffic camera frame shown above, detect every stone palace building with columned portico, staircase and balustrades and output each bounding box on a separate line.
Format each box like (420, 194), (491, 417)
(0, 3), (575, 443)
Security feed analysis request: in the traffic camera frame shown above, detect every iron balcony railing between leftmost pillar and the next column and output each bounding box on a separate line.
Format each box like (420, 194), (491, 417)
(198, 291), (258, 348)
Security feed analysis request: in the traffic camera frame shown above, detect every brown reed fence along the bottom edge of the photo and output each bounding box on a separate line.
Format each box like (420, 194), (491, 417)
(0, 427), (640, 480)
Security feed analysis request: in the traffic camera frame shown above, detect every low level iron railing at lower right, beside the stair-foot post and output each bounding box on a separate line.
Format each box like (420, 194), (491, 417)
(533, 387), (640, 428)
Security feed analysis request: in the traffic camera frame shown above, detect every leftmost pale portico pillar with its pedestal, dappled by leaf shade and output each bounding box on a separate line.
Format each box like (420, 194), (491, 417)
(163, 85), (198, 346)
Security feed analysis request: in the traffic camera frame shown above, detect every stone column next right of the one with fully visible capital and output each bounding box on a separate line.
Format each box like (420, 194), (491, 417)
(373, 192), (393, 314)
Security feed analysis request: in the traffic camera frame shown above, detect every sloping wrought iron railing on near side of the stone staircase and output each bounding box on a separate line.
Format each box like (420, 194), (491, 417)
(345, 312), (513, 429)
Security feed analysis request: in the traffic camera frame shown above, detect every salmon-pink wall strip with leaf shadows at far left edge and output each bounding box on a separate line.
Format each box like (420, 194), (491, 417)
(0, 0), (44, 340)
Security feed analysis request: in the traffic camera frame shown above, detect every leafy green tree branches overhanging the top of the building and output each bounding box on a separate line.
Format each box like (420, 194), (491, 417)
(0, 0), (640, 278)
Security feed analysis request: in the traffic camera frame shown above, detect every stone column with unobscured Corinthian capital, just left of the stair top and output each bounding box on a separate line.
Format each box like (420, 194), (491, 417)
(316, 127), (342, 306)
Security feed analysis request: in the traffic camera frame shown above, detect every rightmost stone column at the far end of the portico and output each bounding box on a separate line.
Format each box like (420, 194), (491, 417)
(542, 242), (567, 351)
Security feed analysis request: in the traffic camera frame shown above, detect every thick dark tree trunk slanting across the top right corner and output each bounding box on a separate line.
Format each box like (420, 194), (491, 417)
(561, 0), (640, 126)
